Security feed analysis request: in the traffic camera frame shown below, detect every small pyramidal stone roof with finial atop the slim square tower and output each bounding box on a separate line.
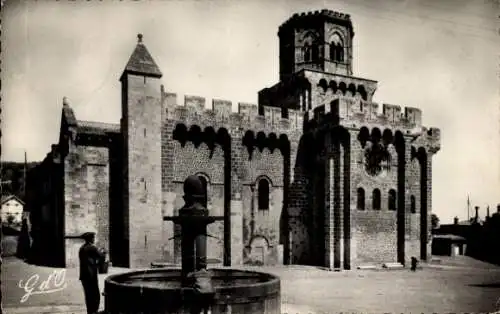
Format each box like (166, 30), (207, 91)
(123, 34), (162, 77)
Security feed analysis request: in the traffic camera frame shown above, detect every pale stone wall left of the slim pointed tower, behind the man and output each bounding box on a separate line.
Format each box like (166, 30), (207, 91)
(64, 146), (109, 267)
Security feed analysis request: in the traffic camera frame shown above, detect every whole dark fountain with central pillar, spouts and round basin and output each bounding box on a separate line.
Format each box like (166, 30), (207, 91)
(104, 176), (281, 314)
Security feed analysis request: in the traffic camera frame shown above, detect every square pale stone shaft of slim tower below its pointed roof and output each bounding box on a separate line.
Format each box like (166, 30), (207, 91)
(122, 74), (163, 268)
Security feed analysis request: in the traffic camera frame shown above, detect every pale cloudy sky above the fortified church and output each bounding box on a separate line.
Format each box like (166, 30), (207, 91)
(0, 0), (500, 223)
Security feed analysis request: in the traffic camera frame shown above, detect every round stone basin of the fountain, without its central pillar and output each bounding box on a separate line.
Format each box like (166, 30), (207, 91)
(104, 269), (281, 314)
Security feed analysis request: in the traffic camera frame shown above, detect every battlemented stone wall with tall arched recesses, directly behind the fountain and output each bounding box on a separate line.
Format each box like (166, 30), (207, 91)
(162, 93), (302, 264)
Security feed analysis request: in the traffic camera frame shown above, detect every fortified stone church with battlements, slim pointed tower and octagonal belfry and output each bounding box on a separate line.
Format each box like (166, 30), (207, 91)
(27, 10), (440, 269)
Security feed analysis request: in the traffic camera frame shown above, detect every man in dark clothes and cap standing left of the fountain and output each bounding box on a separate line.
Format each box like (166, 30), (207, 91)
(78, 232), (103, 314)
